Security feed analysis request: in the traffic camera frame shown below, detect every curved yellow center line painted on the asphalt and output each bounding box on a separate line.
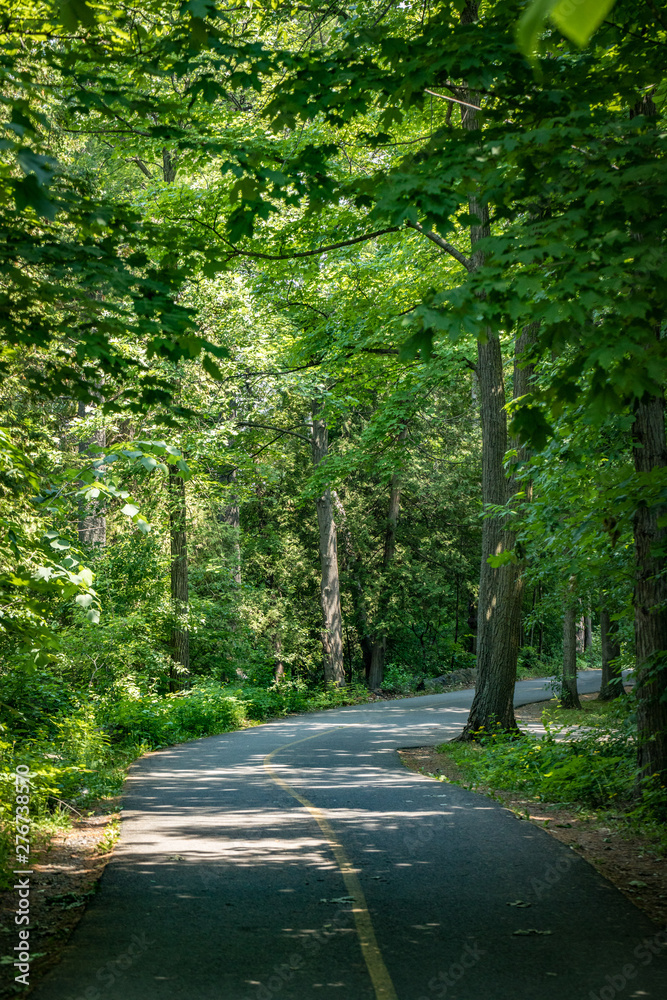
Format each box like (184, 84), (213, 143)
(263, 726), (398, 1000)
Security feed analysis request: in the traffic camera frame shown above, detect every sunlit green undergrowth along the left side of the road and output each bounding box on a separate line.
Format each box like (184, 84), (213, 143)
(0, 671), (368, 888)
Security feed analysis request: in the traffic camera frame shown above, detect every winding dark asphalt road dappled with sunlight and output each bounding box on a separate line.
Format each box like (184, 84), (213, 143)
(32, 674), (667, 1000)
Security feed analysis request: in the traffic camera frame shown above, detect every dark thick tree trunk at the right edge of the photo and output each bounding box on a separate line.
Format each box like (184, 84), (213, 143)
(633, 394), (667, 785)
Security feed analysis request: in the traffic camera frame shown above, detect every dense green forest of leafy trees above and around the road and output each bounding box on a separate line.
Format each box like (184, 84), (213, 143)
(0, 0), (667, 896)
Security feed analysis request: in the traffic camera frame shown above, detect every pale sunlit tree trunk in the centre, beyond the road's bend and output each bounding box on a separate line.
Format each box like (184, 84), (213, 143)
(311, 402), (345, 687)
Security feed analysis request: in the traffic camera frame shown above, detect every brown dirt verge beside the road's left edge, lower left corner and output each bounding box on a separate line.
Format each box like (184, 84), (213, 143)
(0, 800), (117, 1000)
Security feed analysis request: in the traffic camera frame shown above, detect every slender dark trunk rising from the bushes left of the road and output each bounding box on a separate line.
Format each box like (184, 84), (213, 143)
(168, 465), (190, 691)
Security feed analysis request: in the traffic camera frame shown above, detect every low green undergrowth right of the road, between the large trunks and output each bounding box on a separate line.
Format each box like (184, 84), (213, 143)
(437, 697), (667, 848)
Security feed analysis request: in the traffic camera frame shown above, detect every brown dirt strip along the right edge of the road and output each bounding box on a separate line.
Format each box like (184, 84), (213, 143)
(399, 695), (667, 928)
